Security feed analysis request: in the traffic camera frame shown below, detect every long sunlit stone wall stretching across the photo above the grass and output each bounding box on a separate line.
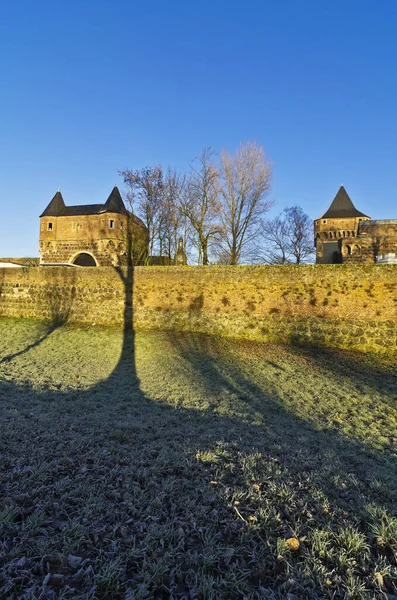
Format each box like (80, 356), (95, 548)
(0, 265), (397, 354)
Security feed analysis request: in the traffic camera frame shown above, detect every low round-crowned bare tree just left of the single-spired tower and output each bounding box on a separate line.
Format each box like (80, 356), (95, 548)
(262, 206), (314, 264)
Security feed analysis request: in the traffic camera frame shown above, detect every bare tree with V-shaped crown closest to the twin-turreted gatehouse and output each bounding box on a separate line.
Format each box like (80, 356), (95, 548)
(120, 165), (164, 255)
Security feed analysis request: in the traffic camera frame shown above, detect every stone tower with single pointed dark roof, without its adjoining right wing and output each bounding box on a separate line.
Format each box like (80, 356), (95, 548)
(314, 185), (370, 264)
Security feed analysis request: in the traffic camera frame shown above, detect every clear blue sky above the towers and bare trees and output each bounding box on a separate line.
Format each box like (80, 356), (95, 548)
(0, 0), (397, 256)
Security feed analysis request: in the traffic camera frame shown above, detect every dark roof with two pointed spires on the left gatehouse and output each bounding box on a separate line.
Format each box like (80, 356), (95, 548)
(40, 186), (145, 227)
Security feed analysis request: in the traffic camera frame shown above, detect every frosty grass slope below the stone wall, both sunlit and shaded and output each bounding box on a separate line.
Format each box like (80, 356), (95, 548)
(0, 319), (397, 600)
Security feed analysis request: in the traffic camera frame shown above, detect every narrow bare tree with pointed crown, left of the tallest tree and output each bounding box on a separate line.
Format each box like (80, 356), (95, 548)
(176, 148), (221, 265)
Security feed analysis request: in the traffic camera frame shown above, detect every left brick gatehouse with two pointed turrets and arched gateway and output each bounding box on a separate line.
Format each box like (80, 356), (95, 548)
(40, 187), (148, 267)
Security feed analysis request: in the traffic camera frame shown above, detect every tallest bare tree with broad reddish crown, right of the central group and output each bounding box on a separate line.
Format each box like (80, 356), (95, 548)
(219, 142), (272, 265)
